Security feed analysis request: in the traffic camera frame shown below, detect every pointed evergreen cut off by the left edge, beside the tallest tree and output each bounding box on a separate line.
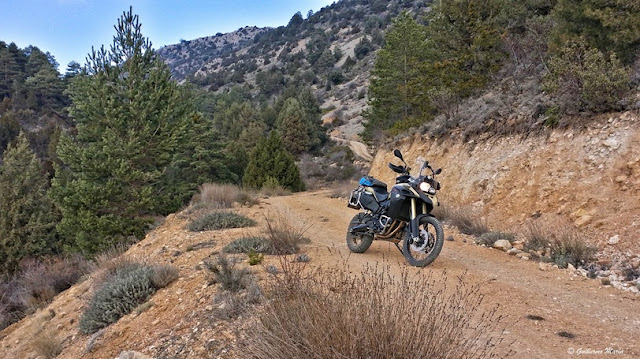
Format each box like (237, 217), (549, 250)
(0, 133), (61, 273)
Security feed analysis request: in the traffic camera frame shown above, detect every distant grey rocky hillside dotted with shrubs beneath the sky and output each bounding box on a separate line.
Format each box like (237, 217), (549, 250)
(159, 0), (429, 139)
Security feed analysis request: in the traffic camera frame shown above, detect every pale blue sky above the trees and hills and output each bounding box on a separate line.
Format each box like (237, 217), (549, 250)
(0, 0), (334, 73)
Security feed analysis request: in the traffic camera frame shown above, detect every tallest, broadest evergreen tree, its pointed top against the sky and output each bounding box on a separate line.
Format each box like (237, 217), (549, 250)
(52, 9), (230, 255)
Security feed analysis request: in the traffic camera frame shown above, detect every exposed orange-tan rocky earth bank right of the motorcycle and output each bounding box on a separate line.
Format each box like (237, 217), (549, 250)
(371, 112), (640, 254)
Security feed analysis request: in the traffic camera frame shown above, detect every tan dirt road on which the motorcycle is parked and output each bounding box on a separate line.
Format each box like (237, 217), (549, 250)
(267, 192), (640, 358)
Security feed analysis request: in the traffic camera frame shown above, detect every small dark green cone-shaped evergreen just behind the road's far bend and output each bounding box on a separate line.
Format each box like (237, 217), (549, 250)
(243, 131), (304, 192)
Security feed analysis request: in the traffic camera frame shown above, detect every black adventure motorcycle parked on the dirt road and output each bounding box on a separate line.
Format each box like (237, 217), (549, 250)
(347, 150), (444, 267)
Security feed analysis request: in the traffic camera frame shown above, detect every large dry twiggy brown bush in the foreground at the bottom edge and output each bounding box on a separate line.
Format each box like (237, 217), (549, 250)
(246, 268), (510, 359)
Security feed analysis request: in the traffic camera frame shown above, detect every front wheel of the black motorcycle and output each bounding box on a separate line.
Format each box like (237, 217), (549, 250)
(402, 216), (444, 267)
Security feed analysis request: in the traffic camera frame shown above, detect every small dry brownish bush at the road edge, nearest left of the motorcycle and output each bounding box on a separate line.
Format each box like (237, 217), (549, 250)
(265, 212), (311, 254)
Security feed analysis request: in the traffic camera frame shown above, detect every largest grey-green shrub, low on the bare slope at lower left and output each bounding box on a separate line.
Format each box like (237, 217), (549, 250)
(79, 265), (156, 334)
